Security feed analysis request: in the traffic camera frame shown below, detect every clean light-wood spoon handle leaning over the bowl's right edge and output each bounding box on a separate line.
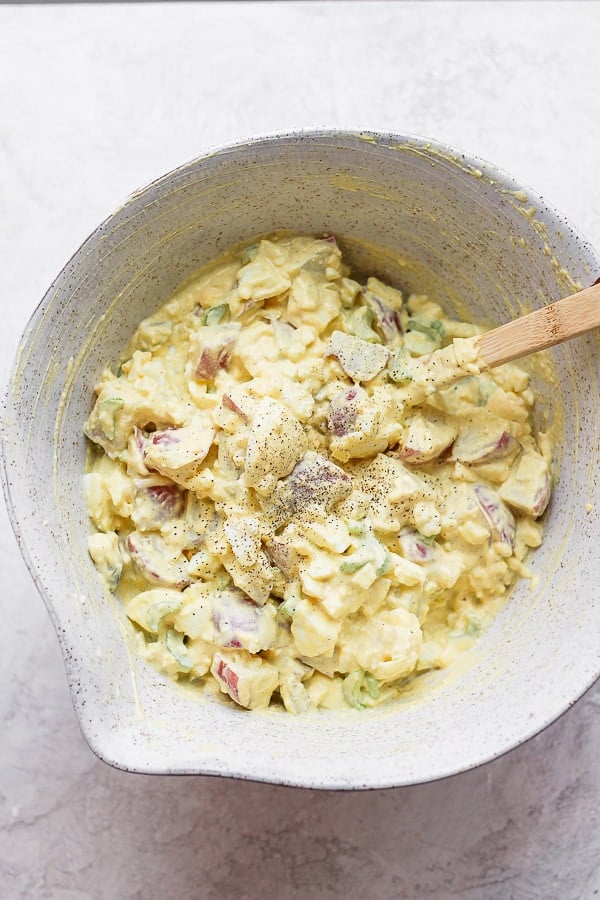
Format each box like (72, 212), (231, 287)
(475, 279), (600, 369)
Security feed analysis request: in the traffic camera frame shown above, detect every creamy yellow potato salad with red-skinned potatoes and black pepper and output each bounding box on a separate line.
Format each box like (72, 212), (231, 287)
(85, 236), (552, 713)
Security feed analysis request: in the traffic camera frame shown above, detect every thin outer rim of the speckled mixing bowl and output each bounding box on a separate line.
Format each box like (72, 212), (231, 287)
(0, 127), (600, 790)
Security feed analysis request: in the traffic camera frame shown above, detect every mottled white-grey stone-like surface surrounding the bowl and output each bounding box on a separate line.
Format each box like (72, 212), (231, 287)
(0, 2), (600, 900)
